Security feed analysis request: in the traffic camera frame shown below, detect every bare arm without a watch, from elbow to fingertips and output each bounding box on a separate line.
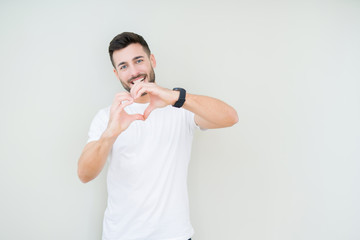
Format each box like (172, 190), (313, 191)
(78, 92), (144, 183)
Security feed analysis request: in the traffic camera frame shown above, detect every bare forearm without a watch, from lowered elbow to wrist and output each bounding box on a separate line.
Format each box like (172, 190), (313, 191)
(78, 134), (116, 183)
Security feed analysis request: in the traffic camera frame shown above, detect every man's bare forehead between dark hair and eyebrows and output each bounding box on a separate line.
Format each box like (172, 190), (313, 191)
(113, 43), (147, 66)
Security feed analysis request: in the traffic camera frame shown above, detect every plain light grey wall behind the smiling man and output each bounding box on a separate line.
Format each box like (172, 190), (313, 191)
(0, 0), (360, 240)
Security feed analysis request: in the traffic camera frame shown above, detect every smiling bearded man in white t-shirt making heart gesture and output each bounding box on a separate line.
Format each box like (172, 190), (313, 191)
(78, 32), (238, 240)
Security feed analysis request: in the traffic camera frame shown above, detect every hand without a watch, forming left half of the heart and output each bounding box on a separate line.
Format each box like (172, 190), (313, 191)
(103, 92), (145, 138)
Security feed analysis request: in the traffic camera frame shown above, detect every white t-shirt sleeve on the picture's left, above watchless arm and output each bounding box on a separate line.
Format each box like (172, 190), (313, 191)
(87, 107), (110, 142)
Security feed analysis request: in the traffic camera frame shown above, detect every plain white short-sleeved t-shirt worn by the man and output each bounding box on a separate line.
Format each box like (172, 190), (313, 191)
(88, 103), (197, 240)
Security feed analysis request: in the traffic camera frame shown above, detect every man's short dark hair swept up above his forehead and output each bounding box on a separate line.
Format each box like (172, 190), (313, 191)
(109, 32), (151, 67)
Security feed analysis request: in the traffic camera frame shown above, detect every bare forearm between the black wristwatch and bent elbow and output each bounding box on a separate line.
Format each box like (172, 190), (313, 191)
(183, 94), (238, 129)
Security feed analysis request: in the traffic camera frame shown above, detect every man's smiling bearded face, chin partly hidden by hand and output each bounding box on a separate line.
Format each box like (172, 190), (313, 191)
(113, 43), (156, 92)
